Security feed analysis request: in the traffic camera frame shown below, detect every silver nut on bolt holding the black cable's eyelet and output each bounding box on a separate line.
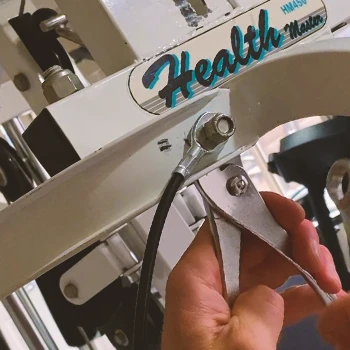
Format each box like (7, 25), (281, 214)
(204, 114), (236, 143)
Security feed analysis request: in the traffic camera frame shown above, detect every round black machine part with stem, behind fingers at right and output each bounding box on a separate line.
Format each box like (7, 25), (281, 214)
(268, 116), (350, 290)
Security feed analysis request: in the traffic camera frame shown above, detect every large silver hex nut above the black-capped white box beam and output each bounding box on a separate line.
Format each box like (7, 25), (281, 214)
(42, 69), (84, 103)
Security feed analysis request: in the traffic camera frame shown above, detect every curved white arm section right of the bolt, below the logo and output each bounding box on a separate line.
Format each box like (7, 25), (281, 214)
(224, 38), (350, 144)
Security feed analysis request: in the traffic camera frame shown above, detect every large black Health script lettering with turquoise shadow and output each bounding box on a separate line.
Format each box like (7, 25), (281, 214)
(142, 10), (285, 108)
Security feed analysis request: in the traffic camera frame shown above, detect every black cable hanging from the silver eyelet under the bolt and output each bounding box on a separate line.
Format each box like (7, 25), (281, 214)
(133, 173), (184, 350)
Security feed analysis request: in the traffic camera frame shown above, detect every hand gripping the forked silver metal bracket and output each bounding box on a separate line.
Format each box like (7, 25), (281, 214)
(162, 193), (341, 350)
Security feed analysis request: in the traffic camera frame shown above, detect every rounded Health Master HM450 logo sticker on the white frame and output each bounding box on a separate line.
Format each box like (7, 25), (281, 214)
(130, 0), (327, 114)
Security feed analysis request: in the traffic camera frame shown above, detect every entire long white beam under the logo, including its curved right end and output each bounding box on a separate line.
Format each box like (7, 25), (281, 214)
(0, 39), (350, 297)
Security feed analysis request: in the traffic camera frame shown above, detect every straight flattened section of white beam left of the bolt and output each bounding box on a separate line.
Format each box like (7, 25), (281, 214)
(0, 90), (234, 296)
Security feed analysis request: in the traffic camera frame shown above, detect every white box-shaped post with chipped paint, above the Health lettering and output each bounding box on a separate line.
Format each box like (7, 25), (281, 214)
(56, 0), (232, 75)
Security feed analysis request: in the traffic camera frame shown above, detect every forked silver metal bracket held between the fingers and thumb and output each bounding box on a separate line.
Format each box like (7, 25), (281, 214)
(198, 165), (336, 305)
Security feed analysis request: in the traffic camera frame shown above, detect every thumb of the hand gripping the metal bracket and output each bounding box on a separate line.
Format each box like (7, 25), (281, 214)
(226, 286), (284, 350)
